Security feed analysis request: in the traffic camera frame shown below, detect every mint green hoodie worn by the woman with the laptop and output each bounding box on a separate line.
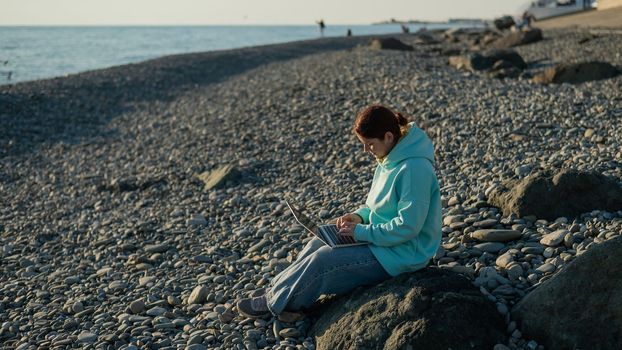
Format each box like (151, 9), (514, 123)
(354, 122), (441, 276)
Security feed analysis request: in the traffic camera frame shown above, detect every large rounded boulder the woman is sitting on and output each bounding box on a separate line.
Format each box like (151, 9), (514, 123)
(310, 267), (506, 350)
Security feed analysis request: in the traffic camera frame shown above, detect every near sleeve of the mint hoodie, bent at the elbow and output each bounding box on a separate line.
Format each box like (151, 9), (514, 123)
(354, 163), (435, 247)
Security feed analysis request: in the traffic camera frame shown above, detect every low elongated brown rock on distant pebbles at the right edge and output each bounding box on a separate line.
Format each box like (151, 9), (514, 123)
(533, 61), (620, 84)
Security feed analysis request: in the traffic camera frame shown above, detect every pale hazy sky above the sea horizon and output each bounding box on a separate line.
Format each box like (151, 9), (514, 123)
(0, 0), (529, 25)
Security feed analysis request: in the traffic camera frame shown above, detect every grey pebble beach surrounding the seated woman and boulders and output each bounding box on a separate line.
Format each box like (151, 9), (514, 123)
(0, 28), (622, 350)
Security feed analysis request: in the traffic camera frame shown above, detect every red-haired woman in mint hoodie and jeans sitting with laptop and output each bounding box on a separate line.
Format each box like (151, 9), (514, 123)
(236, 105), (441, 318)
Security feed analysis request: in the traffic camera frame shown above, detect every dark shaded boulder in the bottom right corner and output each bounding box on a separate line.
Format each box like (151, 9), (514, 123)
(512, 237), (622, 350)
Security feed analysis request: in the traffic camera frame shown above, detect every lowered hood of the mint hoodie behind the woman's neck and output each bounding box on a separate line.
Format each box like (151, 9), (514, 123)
(378, 122), (434, 169)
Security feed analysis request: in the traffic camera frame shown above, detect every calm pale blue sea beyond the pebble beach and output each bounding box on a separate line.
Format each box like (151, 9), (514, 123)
(0, 24), (478, 85)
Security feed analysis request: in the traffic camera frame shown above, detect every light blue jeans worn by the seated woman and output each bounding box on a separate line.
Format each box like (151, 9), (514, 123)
(266, 237), (391, 316)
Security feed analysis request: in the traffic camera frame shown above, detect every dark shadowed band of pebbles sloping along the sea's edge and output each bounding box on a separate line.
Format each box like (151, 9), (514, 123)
(0, 34), (420, 159)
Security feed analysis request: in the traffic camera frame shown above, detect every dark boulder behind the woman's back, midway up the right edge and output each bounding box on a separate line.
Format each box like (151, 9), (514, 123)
(489, 169), (622, 220)
